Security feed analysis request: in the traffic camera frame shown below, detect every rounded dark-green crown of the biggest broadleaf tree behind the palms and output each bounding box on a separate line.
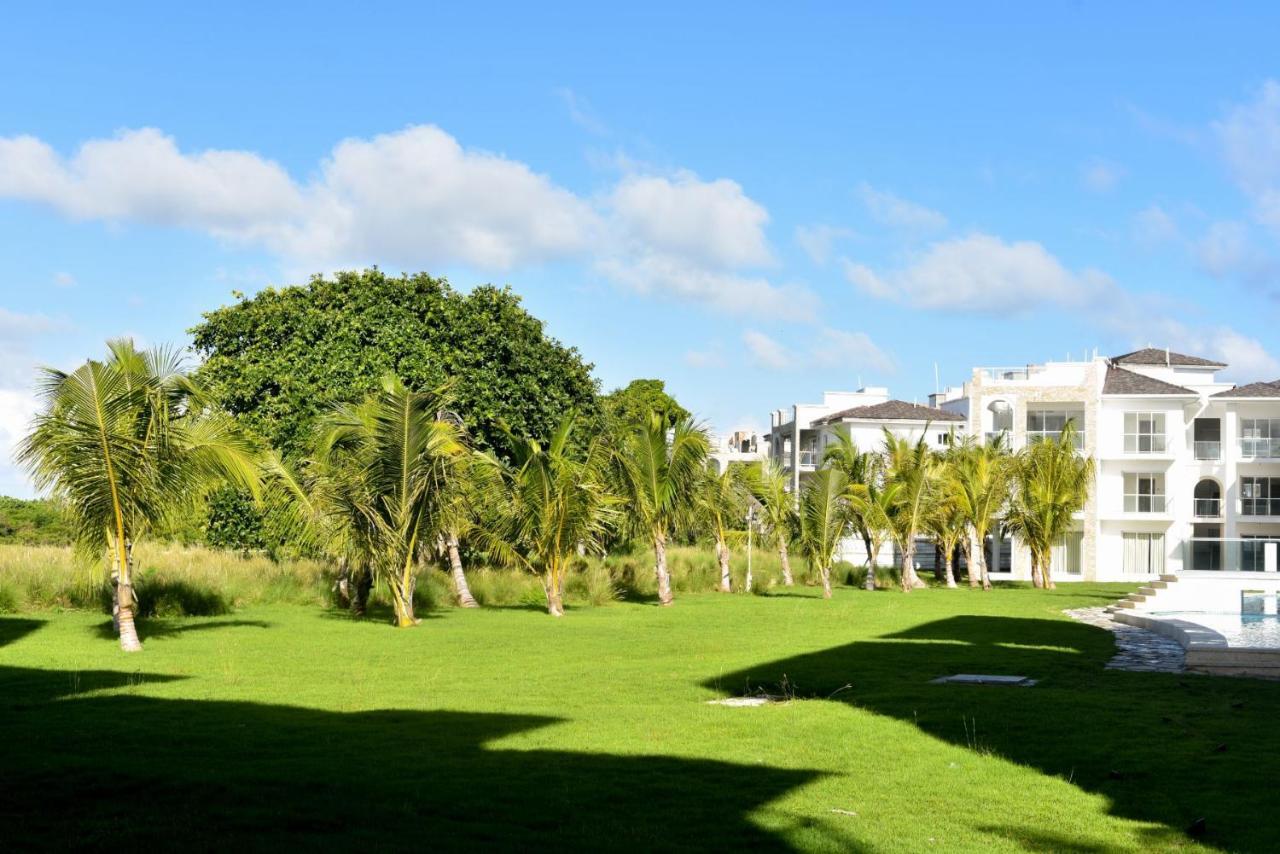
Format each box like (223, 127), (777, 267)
(191, 269), (598, 458)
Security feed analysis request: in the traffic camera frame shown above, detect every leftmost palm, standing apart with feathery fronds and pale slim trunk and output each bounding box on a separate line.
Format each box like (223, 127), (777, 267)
(18, 339), (257, 652)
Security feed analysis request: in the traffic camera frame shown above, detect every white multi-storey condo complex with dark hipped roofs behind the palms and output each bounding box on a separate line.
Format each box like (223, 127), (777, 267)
(767, 348), (1280, 581)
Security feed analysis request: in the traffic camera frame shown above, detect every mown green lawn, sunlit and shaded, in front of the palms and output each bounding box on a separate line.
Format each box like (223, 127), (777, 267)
(0, 585), (1280, 851)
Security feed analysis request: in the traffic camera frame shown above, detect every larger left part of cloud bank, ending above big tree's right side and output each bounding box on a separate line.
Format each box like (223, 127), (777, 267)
(0, 125), (595, 270)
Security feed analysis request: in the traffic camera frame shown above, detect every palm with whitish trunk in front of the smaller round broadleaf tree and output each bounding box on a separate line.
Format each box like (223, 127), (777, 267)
(616, 414), (710, 606)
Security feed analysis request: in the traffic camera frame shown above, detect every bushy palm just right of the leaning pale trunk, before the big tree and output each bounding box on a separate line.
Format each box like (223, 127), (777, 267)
(481, 414), (620, 617)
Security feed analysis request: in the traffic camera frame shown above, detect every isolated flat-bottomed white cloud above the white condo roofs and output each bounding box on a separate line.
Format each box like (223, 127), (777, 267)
(845, 234), (1112, 312)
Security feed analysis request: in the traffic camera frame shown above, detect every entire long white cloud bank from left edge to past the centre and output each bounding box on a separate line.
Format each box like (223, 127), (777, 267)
(0, 123), (817, 319)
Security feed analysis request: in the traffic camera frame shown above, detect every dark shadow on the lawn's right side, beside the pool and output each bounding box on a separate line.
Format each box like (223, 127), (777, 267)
(705, 616), (1280, 851)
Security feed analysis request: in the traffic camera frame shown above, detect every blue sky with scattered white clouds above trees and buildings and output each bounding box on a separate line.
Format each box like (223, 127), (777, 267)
(0, 3), (1280, 494)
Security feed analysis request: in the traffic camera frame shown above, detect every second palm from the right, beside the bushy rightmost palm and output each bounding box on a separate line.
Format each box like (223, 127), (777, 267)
(950, 438), (1014, 590)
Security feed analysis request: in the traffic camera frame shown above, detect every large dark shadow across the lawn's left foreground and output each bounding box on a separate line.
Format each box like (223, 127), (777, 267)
(0, 667), (819, 851)
